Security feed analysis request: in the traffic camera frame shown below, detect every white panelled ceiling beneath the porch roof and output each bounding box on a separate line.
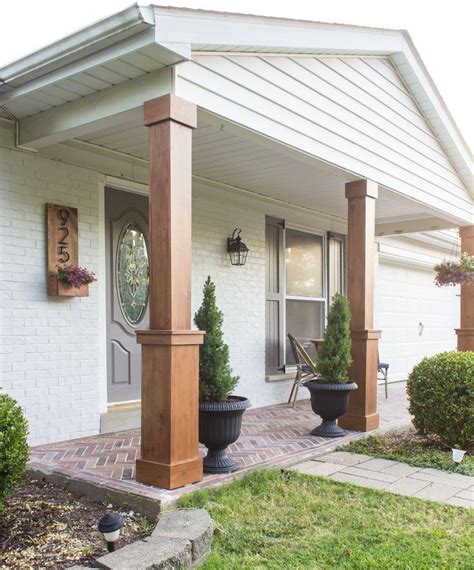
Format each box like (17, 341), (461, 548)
(77, 115), (429, 223)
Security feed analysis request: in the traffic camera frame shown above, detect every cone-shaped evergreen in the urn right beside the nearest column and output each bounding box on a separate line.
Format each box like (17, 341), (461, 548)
(194, 277), (239, 402)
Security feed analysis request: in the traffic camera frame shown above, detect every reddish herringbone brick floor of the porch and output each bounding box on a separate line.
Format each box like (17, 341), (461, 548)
(29, 384), (410, 503)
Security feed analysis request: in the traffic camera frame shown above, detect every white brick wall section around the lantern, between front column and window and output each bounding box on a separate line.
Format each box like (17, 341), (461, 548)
(192, 196), (275, 406)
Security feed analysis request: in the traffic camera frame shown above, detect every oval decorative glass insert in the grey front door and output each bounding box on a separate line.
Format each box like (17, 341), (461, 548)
(116, 222), (149, 326)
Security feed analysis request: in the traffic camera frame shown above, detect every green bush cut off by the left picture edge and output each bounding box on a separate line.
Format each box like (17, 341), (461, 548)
(0, 394), (29, 512)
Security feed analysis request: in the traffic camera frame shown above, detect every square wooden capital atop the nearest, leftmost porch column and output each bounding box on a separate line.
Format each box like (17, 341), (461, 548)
(143, 93), (197, 129)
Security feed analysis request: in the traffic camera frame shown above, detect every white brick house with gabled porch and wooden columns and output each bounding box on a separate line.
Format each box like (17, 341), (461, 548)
(0, 6), (474, 484)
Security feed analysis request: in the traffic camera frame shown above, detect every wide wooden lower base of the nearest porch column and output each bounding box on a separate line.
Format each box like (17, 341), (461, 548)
(136, 330), (203, 489)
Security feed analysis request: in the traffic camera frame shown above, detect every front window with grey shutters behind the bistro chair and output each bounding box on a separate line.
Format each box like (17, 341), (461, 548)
(266, 218), (345, 374)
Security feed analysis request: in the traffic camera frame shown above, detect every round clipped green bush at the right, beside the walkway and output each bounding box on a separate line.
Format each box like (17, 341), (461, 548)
(407, 352), (474, 450)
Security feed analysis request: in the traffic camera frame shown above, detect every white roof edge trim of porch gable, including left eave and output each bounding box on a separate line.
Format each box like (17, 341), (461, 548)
(0, 5), (473, 193)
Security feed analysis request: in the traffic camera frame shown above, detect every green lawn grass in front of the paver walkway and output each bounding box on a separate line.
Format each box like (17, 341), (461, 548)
(179, 470), (474, 570)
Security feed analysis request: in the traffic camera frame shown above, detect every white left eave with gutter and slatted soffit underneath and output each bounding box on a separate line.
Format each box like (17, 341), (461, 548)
(0, 5), (190, 119)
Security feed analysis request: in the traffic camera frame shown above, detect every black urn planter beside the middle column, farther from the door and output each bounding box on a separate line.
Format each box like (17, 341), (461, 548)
(305, 380), (357, 437)
